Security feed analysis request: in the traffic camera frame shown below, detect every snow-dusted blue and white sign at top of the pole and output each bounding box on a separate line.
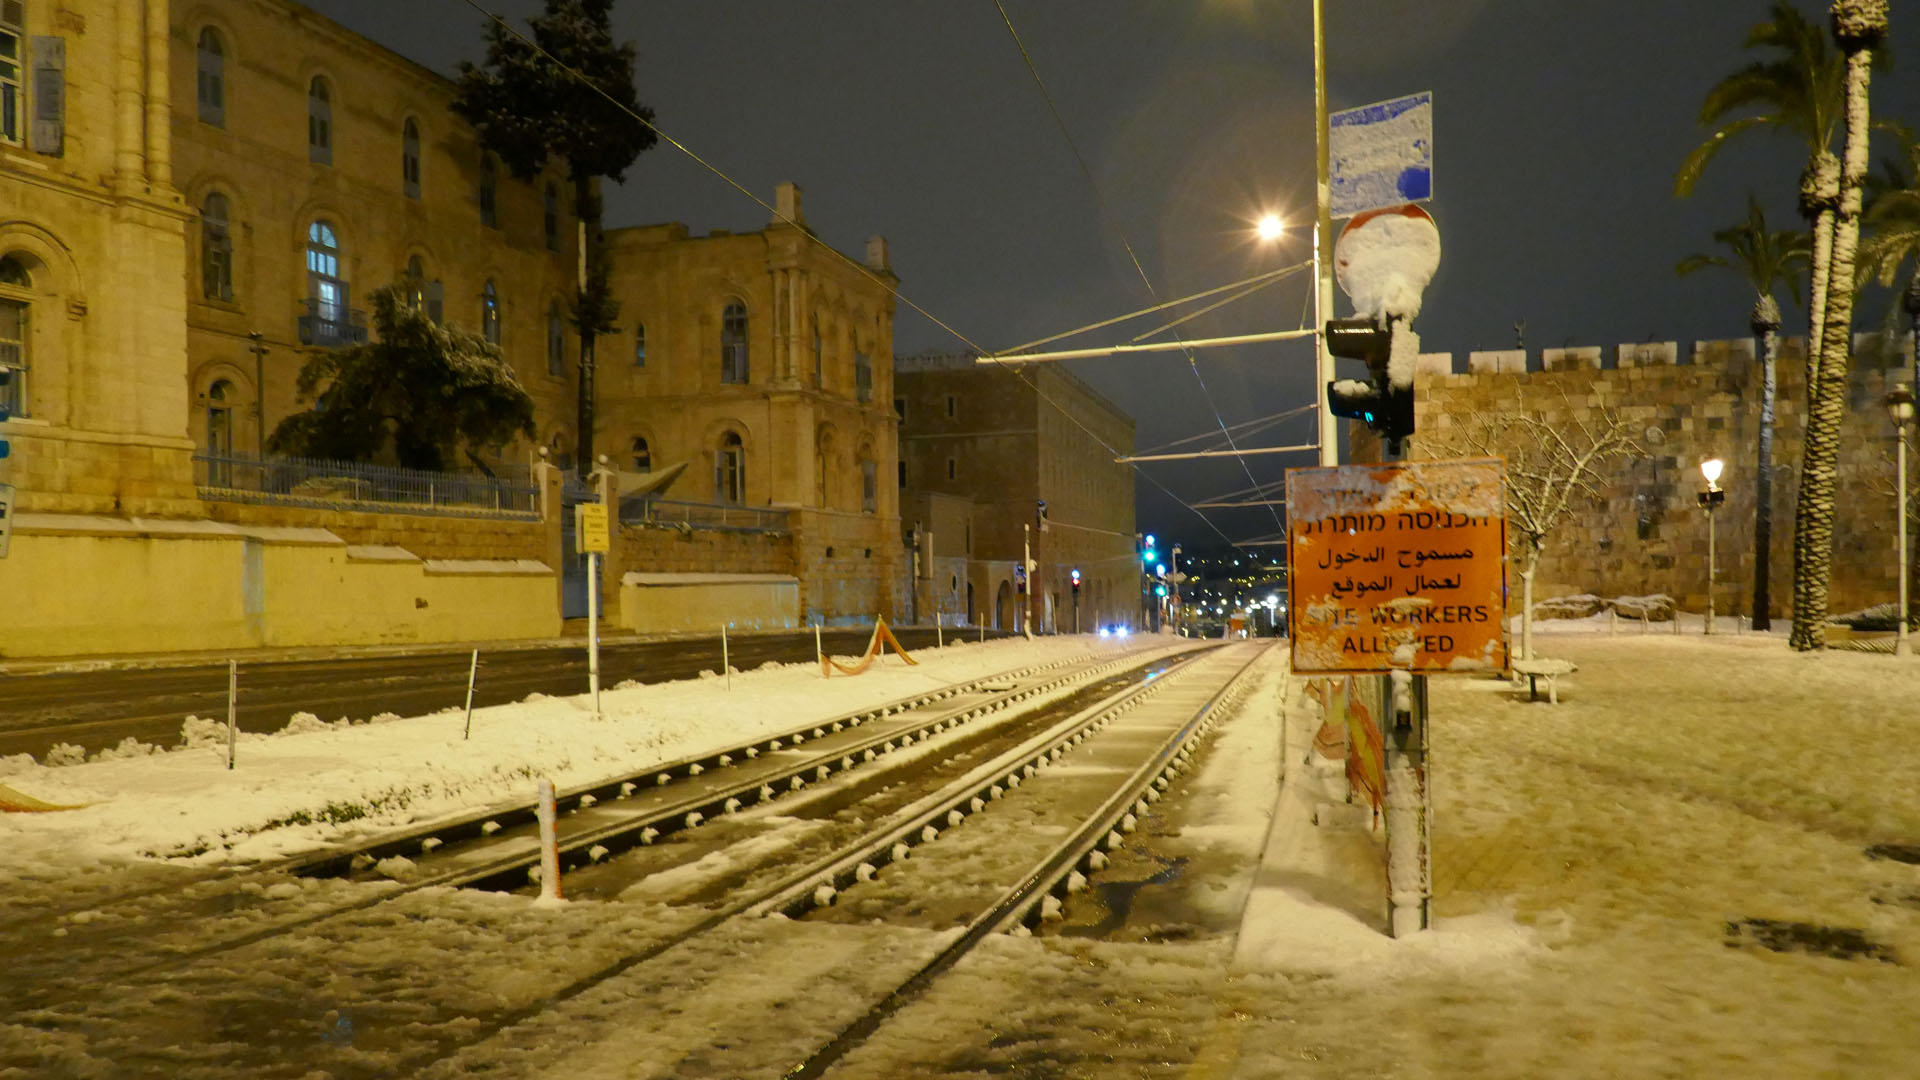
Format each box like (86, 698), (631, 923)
(1327, 92), (1434, 217)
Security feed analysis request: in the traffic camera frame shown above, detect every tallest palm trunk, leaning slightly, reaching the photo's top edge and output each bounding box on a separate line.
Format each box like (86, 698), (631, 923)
(1791, 0), (1887, 651)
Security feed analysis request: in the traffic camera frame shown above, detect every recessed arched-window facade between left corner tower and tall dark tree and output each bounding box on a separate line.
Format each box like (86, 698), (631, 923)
(167, 0), (578, 457)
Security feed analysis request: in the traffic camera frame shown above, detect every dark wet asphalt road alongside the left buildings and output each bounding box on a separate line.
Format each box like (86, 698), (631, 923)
(0, 628), (1004, 757)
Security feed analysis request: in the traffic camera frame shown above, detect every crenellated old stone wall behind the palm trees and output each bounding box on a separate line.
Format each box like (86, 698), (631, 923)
(1397, 338), (1907, 615)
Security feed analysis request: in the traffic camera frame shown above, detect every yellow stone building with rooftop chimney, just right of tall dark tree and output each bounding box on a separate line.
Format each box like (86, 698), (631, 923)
(593, 184), (902, 623)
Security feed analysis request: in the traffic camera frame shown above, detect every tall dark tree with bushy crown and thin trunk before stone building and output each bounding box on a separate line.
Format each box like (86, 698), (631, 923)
(453, 0), (659, 477)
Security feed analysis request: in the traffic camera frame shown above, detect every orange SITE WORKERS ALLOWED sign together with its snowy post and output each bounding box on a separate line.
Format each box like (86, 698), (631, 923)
(1286, 459), (1509, 938)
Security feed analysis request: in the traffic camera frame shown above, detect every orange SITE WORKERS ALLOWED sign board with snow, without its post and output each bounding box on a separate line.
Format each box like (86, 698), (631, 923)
(1286, 457), (1507, 675)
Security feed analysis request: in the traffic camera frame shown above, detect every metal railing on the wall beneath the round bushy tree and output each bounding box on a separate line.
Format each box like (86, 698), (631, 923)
(194, 443), (540, 521)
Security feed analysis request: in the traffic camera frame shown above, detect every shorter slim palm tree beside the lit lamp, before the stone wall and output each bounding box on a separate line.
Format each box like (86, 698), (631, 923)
(1674, 192), (1809, 630)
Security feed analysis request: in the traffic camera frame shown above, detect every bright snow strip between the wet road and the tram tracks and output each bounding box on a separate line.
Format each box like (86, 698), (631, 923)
(0, 636), (1128, 865)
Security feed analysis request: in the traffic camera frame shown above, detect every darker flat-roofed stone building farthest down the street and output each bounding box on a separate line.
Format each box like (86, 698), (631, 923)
(895, 354), (1140, 632)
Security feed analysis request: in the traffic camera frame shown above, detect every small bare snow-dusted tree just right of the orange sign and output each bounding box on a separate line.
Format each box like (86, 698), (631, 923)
(1421, 390), (1640, 659)
